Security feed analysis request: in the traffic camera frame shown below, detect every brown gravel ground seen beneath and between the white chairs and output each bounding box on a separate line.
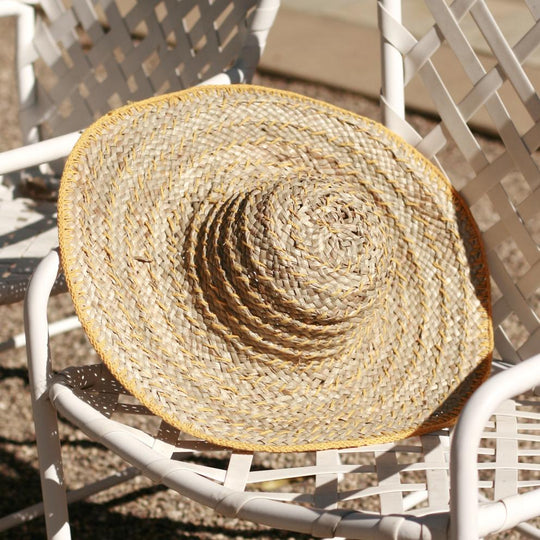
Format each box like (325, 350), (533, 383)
(0, 14), (520, 540)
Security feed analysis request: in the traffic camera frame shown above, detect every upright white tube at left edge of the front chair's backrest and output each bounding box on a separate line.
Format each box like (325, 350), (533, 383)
(379, 0), (405, 129)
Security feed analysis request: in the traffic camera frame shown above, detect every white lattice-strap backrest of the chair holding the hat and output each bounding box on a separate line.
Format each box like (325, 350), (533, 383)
(378, 0), (540, 363)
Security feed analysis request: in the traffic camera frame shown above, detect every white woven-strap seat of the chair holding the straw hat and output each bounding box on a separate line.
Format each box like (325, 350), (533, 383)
(50, 364), (540, 538)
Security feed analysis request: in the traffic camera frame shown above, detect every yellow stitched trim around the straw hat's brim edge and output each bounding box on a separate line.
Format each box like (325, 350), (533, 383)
(58, 85), (494, 452)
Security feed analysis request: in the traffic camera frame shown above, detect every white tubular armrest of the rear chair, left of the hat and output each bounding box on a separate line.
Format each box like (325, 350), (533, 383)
(0, 131), (81, 174)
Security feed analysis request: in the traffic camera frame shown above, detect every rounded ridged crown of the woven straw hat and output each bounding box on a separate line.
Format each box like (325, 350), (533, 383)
(188, 177), (393, 361)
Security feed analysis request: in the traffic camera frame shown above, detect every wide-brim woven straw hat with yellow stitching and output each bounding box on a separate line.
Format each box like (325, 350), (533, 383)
(58, 86), (492, 451)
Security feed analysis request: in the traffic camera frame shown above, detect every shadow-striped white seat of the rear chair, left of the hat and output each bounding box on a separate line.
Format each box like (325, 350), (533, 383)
(0, 177), (67, 304)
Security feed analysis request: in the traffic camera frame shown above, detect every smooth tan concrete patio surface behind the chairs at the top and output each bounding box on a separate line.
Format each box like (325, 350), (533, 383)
(261, 0), (540, 132)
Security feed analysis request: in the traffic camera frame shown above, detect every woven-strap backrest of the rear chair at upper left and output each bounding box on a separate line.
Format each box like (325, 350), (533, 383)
(18, 0), (278, 146)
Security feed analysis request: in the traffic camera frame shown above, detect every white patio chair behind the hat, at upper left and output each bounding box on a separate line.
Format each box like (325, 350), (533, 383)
(0, 0), (276, 350)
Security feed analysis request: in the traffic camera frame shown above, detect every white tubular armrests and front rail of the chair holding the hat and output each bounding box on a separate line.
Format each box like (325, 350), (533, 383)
(21, 255), (540, 540)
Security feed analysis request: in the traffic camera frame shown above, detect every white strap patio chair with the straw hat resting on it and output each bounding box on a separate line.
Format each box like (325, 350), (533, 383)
(19, 0), (540, 540)
